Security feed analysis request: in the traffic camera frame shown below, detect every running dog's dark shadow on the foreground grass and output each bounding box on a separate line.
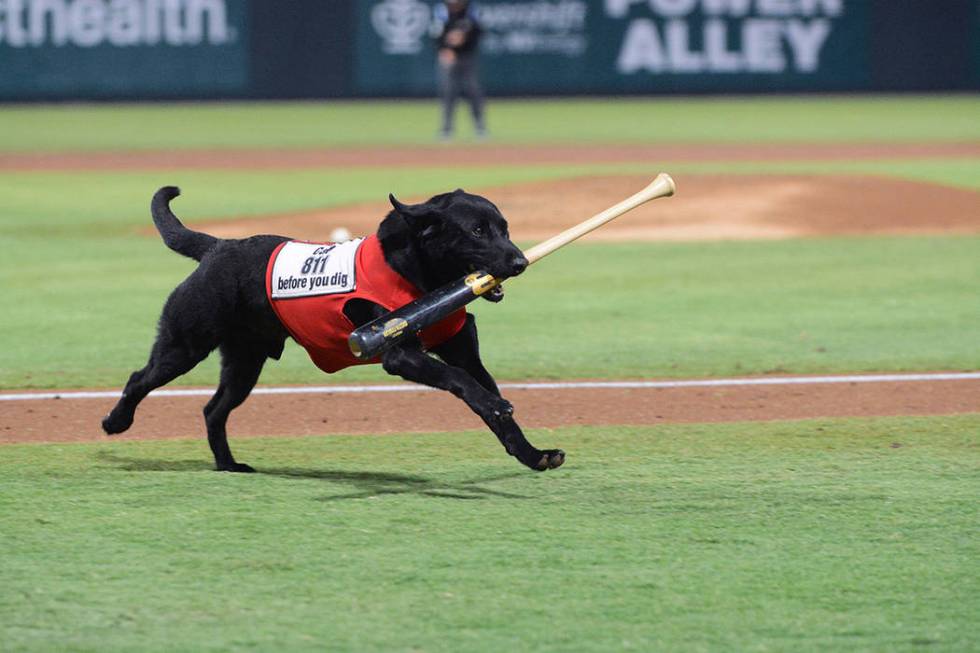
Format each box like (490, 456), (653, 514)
(97, 451), (532, 501)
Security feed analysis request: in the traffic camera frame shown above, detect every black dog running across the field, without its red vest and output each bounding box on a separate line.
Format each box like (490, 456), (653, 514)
(102, 187), (565, 472)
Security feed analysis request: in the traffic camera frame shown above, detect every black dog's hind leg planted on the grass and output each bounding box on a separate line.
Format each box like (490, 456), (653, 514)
(204, 342), (266, 472)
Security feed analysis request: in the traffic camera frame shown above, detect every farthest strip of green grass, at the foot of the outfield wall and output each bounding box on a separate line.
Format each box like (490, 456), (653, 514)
(0, 95), (980, 151)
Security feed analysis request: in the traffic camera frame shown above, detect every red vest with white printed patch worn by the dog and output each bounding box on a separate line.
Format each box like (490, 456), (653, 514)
(265, 236), (466, 373)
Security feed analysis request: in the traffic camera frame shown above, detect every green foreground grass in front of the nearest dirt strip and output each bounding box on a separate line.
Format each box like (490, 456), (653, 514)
(0, 416), (980, 651)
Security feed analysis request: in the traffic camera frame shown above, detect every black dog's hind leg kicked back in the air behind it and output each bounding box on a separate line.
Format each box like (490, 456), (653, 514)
(102, 332), (214, 435)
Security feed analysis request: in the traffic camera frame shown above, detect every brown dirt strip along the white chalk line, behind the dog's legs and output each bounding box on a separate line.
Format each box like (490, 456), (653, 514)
(0, 379), (980, 444)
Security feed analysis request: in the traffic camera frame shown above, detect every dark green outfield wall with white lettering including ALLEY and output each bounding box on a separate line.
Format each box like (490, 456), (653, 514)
(0, 0), (980, 100)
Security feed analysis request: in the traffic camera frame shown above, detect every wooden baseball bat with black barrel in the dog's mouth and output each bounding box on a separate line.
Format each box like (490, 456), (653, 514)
(347, 173), (675, 360)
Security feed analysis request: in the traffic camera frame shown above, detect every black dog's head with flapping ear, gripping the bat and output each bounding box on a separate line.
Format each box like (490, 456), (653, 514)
(378, 189), (527, 300)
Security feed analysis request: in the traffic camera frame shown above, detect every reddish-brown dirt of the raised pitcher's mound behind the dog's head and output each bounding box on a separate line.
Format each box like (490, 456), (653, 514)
(197, 174), (980, 242)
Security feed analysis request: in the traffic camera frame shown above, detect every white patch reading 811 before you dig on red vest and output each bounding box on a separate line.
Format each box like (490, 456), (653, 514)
(270, 238), (364, 299)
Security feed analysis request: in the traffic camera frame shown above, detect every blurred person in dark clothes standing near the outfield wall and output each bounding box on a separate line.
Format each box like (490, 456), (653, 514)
(435, 0), (487, 140)
